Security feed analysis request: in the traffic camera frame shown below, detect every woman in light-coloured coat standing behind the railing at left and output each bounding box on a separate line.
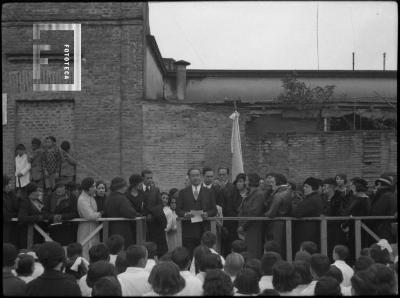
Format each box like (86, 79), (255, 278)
(77, 177), (102, 260)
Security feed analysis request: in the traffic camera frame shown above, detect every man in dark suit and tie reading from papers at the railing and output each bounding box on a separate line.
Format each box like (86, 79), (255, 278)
(176, 168), (217, 257)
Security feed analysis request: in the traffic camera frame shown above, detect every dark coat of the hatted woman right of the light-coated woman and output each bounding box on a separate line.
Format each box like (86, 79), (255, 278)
(104, 191), (140, 247)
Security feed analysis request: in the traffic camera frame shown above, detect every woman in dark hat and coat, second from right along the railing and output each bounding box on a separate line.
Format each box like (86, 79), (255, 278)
(341, 177), (371, 264)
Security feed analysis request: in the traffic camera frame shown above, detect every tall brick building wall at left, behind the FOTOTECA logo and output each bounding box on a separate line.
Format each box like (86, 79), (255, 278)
(2, 2), (147, 184)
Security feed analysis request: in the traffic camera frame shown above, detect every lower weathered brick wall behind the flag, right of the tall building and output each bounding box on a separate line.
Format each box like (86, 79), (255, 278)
(143, 103), (397, 190)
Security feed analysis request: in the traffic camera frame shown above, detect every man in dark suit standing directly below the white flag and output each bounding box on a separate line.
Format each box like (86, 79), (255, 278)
(218, 167), (241, 257)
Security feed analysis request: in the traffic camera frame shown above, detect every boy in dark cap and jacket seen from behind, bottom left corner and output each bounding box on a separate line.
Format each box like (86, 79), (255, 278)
(26, 241), (81, 296)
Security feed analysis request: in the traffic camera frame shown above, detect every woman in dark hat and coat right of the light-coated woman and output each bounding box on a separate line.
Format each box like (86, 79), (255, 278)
(104, 177), (140, 247)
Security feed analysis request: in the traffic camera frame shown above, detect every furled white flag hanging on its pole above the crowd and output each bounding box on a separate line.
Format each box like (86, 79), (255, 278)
(229, 111), (244, 181)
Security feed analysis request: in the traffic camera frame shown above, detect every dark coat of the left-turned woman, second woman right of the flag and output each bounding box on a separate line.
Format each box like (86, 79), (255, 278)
(239, 189), (265, 259)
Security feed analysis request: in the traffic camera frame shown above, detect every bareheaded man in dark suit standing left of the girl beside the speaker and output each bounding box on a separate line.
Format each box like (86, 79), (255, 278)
(140, 170), (168, 257)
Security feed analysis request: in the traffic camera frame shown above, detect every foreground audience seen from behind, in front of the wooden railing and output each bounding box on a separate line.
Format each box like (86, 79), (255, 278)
(3, 231), (398, 297)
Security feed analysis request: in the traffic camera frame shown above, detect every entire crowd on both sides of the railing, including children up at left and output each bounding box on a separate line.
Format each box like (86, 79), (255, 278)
(3, 136), (397, 296)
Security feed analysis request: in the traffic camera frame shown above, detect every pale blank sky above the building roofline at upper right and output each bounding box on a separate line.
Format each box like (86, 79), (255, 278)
(149, 1), (398, 70)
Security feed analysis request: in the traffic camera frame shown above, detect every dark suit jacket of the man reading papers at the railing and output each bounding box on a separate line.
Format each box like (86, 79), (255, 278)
(176, 185), (217, 238)
